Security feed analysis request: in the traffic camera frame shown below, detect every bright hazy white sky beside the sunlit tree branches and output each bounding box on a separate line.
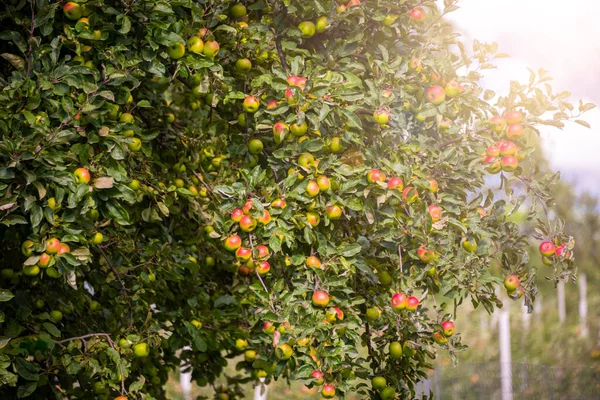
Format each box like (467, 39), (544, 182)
(440, 0), (600, 197)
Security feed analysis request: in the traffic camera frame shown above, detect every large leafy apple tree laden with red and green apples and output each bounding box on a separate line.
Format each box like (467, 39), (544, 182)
(0, 0), (593, 399)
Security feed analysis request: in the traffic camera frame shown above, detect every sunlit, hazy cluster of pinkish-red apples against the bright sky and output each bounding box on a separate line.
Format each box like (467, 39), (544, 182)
(482, 111), (525, 174)
